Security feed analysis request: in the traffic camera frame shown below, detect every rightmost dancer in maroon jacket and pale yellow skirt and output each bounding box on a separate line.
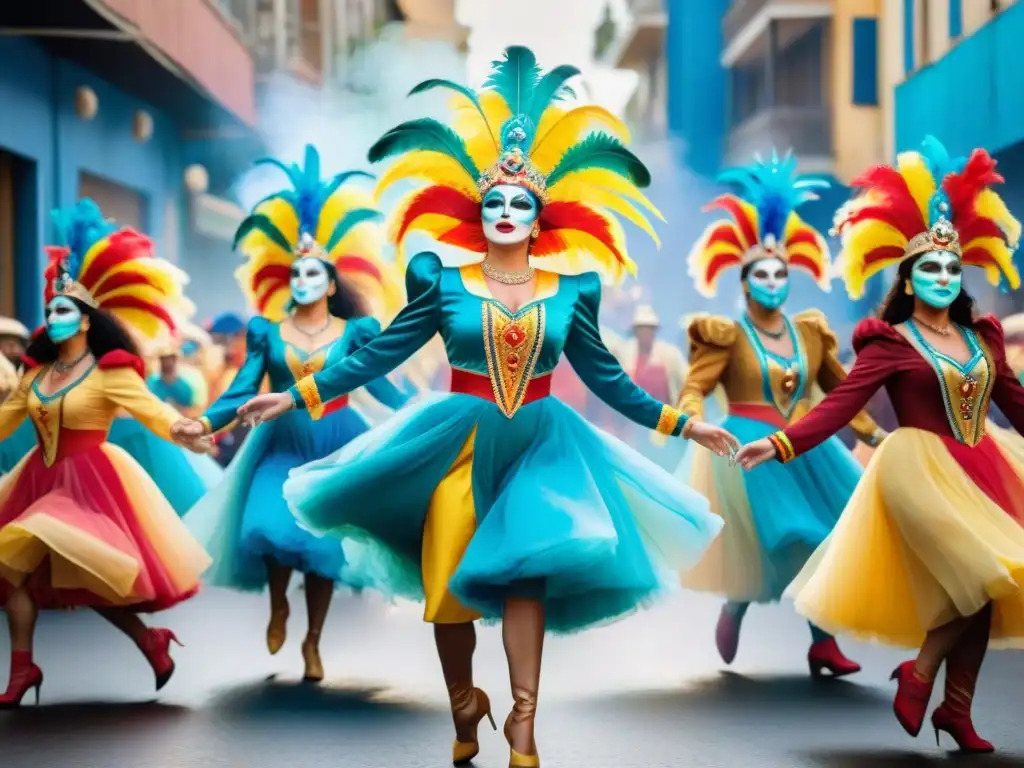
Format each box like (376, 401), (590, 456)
(740, 137), (1024, 752)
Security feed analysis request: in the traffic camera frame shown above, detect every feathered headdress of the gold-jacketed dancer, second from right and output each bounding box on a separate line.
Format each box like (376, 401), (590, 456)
(687, 153), (831, 297)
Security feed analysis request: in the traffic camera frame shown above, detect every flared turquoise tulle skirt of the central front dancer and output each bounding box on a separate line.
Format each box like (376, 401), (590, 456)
(285, 394), (722, 632)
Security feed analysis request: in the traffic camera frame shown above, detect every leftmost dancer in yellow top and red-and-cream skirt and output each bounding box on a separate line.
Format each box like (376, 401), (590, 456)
(0, 200), (210, 709)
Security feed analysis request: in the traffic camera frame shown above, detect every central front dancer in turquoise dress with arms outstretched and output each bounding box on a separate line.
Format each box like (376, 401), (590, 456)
(224, 46), (732, 766)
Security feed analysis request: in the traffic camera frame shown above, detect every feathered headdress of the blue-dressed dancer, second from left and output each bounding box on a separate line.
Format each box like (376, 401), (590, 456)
(234, 145), (403, 321)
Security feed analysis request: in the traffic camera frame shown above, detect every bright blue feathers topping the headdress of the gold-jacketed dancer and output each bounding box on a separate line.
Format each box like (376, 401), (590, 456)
(719, 152), (830, 240)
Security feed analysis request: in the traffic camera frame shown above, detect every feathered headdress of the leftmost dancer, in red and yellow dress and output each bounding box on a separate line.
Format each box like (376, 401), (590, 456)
(44, 200), (195, 340)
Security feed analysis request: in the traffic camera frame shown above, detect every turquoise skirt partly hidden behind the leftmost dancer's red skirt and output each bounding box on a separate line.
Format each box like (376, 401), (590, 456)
(108, 417), (224, 516)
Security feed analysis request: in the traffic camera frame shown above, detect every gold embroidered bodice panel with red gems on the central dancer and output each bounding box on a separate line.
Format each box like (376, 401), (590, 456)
(481, 301), (545, 419)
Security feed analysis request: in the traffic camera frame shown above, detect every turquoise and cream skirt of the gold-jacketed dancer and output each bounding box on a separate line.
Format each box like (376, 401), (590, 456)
(676, 416), (862, 602)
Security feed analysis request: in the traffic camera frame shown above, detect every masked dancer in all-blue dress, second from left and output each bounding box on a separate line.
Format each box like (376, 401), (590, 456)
(180, 146), (408, 681)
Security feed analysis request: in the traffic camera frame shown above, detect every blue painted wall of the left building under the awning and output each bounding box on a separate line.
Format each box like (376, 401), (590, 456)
(0, 38), (183, 326)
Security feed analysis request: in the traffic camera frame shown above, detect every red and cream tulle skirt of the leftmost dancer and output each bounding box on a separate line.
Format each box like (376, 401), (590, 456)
(0, 443), (210, 612)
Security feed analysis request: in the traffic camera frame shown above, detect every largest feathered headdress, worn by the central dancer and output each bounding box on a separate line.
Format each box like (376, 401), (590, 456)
(370, 46), (662, 280)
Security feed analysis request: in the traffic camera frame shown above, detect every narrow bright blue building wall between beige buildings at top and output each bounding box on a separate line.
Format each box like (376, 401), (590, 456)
(665, 0), (729, 175)
